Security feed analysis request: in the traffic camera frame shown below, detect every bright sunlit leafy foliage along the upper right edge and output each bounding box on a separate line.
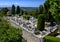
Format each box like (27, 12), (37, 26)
(49, 0), (60, 24)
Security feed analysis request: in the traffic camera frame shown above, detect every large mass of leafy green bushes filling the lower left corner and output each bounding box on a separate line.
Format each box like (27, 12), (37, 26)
(0, 16), (24, 42)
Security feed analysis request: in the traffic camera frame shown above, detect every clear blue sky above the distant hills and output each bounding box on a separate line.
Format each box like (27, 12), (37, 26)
(0, 0), (45, 7)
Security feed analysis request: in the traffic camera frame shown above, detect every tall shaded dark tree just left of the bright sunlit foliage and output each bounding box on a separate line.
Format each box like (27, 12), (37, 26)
(44, 0), (55, 25)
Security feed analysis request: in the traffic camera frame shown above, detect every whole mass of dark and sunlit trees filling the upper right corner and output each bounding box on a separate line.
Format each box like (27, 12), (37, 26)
(44, 0), (60, 24)
